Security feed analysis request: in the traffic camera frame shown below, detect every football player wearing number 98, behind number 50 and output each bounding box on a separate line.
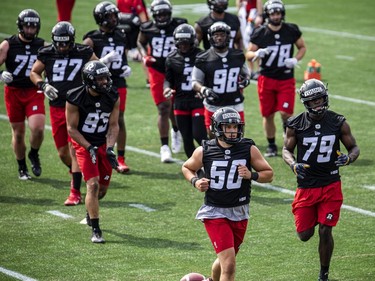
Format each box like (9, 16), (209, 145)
(192, 22), (250, 137)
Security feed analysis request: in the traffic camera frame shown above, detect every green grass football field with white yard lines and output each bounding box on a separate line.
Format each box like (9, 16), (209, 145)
(0, 0), (375, 281)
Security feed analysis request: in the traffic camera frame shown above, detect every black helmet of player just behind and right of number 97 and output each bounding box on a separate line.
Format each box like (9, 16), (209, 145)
(93, 1), (119, 29)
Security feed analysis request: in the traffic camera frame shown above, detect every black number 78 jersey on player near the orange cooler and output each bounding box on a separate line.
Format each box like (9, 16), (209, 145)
(250, 23), (302, 80)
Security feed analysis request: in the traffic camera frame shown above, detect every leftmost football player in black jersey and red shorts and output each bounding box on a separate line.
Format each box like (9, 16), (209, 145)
(0, 9), (45, 180)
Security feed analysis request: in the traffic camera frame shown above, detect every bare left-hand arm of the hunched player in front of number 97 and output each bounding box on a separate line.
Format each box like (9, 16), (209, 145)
(65, 102), (91, 149)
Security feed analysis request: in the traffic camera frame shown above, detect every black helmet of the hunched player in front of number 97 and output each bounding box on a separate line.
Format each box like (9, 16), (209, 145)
(82, 60), (112, 94)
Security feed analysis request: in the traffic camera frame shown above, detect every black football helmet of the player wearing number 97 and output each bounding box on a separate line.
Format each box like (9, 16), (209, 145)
(52, 21), (76, 52)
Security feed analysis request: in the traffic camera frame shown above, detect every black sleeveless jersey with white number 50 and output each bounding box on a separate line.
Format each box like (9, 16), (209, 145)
(202, 138), (255, 208)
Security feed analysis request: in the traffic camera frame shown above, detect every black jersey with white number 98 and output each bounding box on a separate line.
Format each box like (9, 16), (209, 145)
(195, 48), (245, 106)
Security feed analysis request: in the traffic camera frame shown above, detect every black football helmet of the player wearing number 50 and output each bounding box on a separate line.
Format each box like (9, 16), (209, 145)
(210, 107), (245, 144)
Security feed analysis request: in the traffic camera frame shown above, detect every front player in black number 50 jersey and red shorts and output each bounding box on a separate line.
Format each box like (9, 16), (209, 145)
(182, 107), (273, 281)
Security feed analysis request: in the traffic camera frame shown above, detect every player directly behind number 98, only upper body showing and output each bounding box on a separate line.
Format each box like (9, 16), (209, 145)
(195, 0), (243, 50)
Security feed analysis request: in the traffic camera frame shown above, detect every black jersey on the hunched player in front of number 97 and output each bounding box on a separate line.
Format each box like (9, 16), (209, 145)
(67, 86), (118, 147)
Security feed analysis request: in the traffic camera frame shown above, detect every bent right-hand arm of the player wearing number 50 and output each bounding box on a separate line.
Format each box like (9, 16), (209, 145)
(250, 145), (273, 183)
